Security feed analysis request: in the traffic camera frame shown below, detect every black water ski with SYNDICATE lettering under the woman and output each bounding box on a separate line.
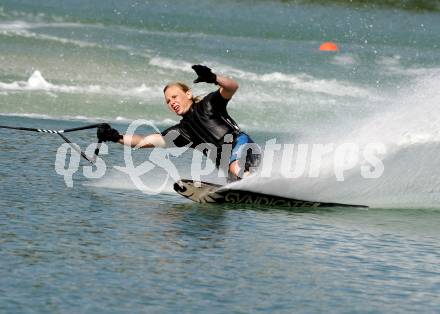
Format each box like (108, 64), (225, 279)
(174, 179), (368, 207)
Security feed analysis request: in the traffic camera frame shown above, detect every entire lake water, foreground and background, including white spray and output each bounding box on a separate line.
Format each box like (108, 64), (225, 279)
(0, 0), (440, 313)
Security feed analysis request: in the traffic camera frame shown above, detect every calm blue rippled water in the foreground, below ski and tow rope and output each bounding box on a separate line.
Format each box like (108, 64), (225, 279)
(0, 118), (440, 313)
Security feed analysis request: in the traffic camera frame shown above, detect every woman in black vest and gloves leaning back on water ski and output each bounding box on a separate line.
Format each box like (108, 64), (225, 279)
(97, 65), (260, 180)
